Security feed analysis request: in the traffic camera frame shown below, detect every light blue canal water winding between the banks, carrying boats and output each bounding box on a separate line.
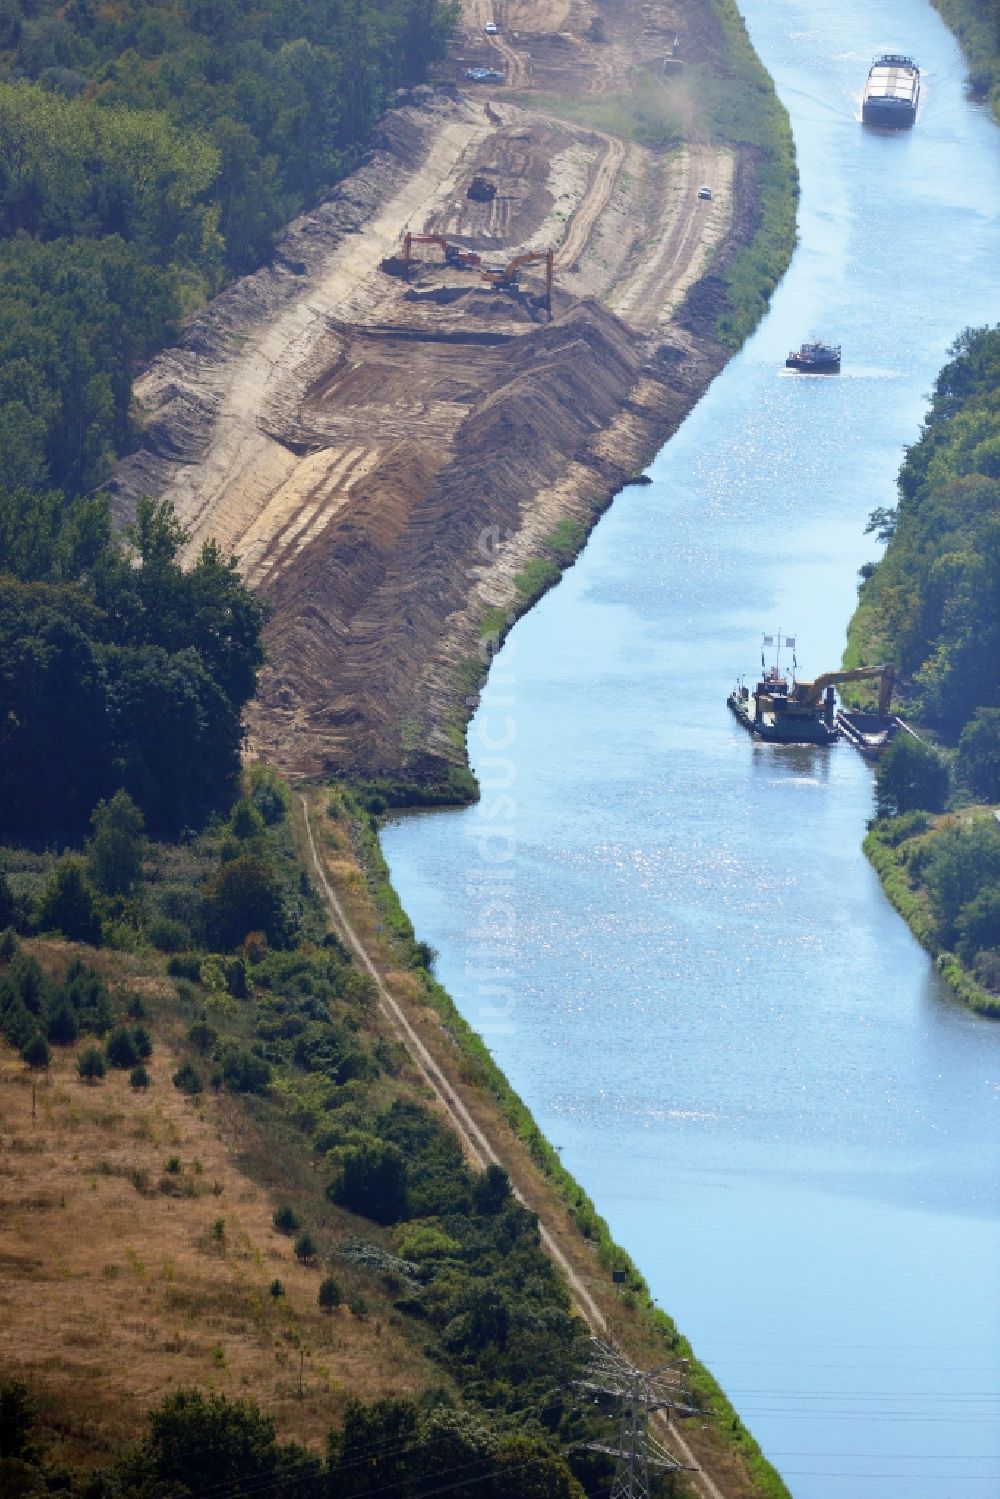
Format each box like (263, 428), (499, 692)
(384, 0), (1000, 1499)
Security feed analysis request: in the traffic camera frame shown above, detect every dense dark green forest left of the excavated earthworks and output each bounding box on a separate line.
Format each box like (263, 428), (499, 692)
(0, 0), (453, 839)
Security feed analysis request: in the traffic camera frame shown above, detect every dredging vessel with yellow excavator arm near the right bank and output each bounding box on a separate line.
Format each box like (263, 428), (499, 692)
(726, 634), (892, 745)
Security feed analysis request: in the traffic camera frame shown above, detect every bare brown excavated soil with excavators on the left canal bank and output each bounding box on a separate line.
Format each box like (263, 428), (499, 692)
(111, 0), (757, 778)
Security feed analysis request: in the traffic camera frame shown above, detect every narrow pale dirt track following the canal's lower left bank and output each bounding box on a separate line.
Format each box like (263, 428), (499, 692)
(300, 793), (726, 1499)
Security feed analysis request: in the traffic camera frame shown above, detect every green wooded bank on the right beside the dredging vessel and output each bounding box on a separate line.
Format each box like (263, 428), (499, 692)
(846, 327), (1000, 1013)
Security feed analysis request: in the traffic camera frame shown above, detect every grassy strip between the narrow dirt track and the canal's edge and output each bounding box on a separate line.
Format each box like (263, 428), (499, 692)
(340, 787), (787, 1499)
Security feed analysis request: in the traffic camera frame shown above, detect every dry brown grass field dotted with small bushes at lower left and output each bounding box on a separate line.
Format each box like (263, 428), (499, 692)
(0, 944), (441, 1465)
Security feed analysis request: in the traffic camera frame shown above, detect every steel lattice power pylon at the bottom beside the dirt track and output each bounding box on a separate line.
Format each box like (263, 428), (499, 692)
(577, 1337), (697, 1499)
